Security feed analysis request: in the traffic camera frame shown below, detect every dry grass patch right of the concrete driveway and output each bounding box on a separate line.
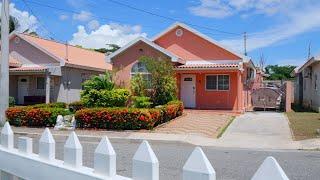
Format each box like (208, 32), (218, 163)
(287, 112), (320, 140)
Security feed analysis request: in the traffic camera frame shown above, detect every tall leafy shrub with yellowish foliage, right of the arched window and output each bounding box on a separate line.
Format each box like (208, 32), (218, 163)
(139, 56), (177, 106)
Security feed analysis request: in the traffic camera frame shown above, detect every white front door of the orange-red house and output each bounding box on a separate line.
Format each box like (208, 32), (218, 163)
(180, 74), (196, 108)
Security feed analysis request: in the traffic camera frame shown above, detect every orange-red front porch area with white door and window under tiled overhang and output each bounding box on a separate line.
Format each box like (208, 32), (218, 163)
(177, 69), (244, 112)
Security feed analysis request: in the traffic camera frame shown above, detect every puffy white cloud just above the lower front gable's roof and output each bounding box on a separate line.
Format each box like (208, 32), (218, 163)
(70, 23), (147, 48)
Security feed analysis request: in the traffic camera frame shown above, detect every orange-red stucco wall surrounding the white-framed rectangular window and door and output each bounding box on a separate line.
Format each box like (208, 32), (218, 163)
(177, 70), (243, 111)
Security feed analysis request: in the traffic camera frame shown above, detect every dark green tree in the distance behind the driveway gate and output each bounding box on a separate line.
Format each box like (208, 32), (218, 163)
(265, 65), (296, 80)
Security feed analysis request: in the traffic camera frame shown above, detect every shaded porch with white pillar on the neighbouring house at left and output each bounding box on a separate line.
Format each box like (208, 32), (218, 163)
(9, 67), (60, 105)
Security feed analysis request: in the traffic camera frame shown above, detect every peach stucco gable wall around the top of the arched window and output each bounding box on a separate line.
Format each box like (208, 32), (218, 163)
(112, 42), (167, 87)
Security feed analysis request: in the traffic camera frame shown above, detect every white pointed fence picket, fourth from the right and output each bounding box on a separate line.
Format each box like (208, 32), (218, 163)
(94, 136), (117, 177)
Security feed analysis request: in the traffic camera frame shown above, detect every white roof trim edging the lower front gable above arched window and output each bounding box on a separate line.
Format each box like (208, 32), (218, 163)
(106, 37), (182, 62)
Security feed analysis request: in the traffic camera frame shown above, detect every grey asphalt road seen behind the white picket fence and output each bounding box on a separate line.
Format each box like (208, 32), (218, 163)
(12, 137), (320, 180)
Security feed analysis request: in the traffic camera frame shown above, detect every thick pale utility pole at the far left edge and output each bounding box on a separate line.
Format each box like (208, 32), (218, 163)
(0, 0), (9, 124)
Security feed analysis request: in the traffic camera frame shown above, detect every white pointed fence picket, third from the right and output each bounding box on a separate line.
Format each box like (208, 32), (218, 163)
(132, 141), (159, 180)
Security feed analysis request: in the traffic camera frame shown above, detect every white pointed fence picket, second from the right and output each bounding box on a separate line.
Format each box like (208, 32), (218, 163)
(182, 147), (216, 180)
